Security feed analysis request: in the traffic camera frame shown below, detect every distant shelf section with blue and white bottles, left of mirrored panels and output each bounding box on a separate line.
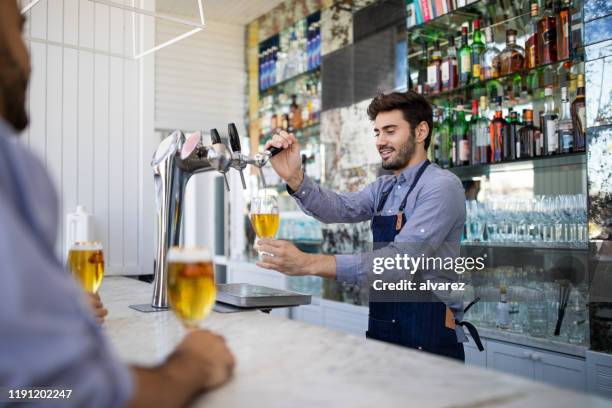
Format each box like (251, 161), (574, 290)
(258, 12), (321, 92)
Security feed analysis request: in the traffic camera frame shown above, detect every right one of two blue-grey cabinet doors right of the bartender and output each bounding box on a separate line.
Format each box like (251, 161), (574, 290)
(531, 351), (587, 391)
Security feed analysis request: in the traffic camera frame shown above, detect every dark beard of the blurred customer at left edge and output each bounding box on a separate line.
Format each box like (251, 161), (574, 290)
(0, 69), (29, 132)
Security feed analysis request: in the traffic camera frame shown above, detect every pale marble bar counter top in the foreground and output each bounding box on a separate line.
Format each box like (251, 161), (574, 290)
(100, 277), (612, 408)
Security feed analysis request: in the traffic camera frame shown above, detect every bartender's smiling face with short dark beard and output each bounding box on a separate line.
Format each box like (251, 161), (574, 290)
(374, 109), (415, 170)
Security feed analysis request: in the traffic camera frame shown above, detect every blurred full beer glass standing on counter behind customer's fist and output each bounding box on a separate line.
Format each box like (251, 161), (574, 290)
(166, 247), (217, 329)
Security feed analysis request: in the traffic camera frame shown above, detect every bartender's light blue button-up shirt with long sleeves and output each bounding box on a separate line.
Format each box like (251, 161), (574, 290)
(292, 159), (465, 341)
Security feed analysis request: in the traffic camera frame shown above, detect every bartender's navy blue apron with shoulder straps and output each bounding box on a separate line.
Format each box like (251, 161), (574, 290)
(366, 160), (482, 361)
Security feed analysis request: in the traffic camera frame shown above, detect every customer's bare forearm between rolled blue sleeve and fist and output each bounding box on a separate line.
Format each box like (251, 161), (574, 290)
(128, 355), (200, 408)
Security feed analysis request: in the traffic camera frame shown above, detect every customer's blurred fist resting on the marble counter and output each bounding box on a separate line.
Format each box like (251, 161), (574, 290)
(174, 330), (235, 390)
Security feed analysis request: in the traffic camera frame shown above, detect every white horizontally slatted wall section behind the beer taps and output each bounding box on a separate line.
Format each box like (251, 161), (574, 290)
(155, 19), (248, 255)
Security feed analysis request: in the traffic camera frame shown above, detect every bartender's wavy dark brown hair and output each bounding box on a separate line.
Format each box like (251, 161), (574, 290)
(368, 91), (433, 150)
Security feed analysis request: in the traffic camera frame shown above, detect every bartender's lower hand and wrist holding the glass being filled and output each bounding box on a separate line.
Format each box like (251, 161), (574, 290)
(257, 238), (336, 279)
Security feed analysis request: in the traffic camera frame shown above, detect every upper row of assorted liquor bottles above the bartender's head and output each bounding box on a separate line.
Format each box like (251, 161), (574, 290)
(408, 0), (583, 101)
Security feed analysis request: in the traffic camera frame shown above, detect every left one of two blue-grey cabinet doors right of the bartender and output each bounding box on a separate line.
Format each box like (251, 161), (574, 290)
(486, 340), (535, 379)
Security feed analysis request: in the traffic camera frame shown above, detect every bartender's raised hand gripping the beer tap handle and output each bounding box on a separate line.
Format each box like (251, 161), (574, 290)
(265, 130), (304, 191)
